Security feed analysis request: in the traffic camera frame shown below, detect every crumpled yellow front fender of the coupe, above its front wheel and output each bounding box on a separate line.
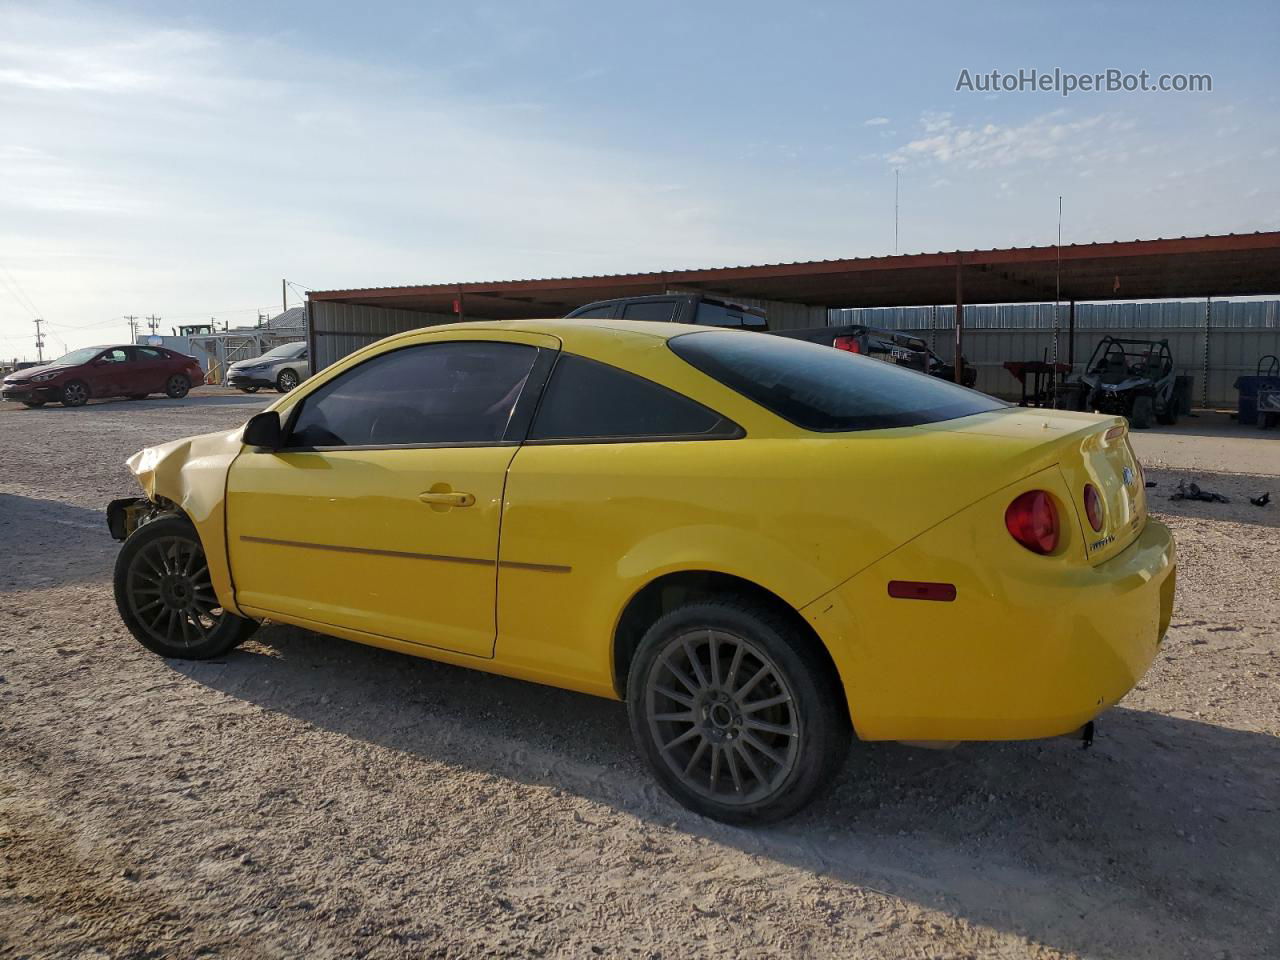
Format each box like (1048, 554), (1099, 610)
(125, 428), (243, 616)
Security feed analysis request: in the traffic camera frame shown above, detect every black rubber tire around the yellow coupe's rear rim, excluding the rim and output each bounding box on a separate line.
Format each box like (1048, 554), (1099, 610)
(627, 600), (850, 824)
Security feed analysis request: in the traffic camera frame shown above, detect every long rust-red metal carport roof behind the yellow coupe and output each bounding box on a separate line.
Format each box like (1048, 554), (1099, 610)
(310, 230), (1280, 319)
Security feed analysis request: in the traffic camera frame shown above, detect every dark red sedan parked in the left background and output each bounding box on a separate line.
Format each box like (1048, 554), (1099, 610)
(0, 344), (205, 407)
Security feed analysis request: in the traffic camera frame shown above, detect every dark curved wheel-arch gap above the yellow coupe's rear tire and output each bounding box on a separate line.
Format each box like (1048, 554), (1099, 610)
(612, 570), (849, 717)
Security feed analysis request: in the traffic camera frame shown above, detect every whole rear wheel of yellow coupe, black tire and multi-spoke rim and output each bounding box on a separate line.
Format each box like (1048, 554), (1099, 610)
(627, 599), (851, 824)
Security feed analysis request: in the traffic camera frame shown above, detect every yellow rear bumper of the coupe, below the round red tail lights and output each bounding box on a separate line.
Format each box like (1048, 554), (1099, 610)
(803, 498), (1175, 740)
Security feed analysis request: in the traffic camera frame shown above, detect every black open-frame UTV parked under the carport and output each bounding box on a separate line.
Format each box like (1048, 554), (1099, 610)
(1073, 337), (1190, 430)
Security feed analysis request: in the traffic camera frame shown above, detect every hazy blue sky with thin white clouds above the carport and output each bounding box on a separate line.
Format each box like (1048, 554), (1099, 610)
(0, 0), (1280, 358)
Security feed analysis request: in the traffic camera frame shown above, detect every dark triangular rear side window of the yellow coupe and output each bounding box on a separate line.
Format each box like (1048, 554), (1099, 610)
(529, 353), (741, 440)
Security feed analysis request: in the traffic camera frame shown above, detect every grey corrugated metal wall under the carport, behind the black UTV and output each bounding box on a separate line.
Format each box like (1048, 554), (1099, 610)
(831, 301), (1280, 407)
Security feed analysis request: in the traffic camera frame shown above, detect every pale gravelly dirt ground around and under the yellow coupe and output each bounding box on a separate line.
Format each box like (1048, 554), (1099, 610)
(0, 392), (1280, 957)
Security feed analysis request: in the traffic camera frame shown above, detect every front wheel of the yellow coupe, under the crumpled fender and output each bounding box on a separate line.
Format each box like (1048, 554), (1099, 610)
(115, 516), (257, 660)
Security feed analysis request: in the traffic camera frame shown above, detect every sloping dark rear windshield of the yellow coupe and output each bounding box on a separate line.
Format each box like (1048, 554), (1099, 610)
(667, 330), (1006, 433)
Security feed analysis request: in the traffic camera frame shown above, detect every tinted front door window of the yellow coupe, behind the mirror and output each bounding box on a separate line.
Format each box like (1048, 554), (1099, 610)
(287, 342), (538, 447)
